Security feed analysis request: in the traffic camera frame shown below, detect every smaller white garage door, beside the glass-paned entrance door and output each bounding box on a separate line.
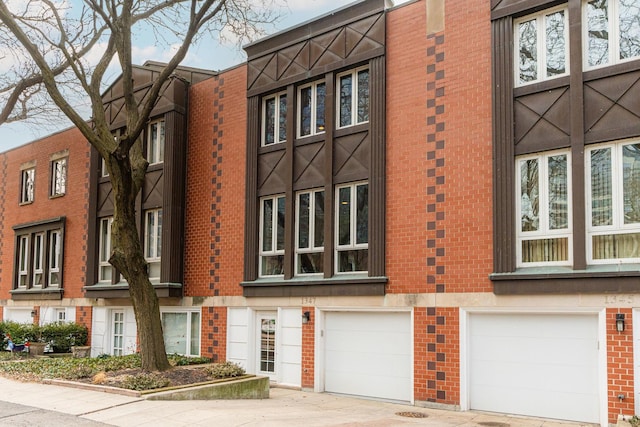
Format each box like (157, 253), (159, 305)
(324, 312), (413, 401)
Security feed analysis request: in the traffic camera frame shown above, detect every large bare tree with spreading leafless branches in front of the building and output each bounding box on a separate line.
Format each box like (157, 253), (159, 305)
(0, 0), (274, 371)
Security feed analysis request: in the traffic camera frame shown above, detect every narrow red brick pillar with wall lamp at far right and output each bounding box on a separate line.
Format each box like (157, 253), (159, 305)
(607, 308), (635, 424)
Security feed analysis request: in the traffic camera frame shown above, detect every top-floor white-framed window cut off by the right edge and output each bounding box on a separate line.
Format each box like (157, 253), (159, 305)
(583, 0), (640, 68)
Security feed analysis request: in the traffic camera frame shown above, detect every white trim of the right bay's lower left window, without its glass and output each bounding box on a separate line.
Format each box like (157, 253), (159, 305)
(515, 150), (573, 267)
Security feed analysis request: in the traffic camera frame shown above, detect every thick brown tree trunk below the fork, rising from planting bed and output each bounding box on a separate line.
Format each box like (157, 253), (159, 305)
(109, 154), (170, 371)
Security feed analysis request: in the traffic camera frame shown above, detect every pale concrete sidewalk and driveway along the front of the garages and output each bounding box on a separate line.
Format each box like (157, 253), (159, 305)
(0, 377), (592, 427)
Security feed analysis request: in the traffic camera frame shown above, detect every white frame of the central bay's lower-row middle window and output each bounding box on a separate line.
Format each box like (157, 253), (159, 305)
(294, 188), (326, 276)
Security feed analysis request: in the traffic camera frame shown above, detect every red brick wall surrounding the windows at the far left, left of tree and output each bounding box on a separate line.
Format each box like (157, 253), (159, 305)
(0, 129), (89, 299)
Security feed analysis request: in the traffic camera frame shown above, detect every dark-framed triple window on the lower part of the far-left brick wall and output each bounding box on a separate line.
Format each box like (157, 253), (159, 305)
(14, 219), (64, 289)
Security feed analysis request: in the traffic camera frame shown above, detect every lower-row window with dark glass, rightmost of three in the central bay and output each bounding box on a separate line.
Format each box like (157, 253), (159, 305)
(336, 183), (369, 273)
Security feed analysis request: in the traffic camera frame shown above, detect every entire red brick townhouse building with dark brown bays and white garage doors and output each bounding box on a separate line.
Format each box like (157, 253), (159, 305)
(0, 0), (640, 426)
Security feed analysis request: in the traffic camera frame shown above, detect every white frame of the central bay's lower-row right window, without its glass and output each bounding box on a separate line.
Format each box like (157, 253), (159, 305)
(334, 181), (370, 274)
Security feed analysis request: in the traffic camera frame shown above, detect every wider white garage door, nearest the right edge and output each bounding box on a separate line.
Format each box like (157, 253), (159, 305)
(468, 313), (599, 423)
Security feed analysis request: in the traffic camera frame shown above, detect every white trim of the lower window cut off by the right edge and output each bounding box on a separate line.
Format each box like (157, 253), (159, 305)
(584, 139), (640, 265)
